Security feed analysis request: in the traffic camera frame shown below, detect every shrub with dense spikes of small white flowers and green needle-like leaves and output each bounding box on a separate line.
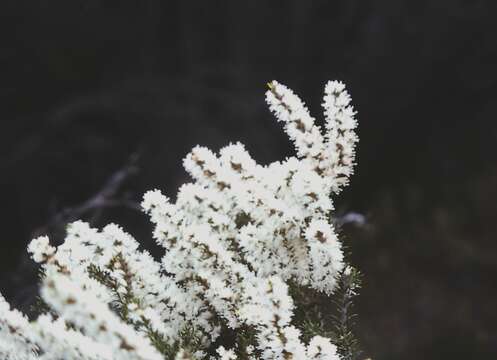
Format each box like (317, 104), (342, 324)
(0, 81), (357, 360)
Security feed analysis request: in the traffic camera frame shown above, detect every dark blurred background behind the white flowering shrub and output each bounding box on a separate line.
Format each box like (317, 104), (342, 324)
(0, 0), (497, 360)
